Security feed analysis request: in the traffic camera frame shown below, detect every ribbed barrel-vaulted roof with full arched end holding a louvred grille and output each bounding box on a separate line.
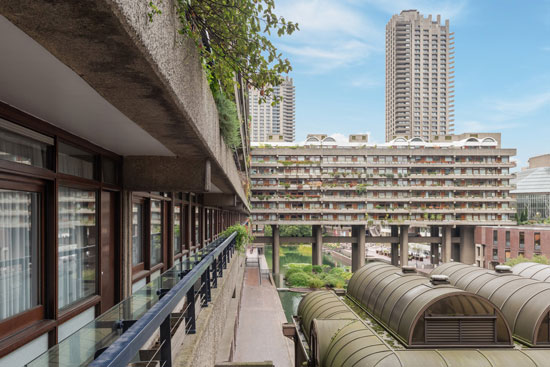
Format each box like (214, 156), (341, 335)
(348, 262), (512, 347)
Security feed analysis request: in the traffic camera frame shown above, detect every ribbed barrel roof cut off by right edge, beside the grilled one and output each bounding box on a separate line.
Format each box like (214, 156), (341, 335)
(432, 262), (550, 346)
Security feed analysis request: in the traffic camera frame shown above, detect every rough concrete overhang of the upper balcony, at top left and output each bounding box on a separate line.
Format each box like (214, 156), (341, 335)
(0, 0), (247, 205)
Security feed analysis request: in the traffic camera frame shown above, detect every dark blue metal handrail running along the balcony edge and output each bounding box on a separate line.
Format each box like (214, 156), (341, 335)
(90, 232), (237, 367)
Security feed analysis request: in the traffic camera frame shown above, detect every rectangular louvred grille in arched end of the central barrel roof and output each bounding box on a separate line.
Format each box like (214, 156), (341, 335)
(425, 318), (496, 344)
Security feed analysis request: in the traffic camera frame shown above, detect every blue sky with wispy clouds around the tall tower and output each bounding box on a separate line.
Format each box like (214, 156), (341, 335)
(274, 0), (550, 167)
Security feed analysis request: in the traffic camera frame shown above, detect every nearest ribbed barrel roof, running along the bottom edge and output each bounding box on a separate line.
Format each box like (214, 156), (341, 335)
(298, 291), (550, 367)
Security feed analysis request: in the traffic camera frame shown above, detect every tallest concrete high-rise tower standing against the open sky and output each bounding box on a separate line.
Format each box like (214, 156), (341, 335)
(386, 10), (454, 142)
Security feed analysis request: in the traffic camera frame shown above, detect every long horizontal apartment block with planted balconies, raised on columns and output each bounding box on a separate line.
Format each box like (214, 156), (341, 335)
(251, 134), (516, 226)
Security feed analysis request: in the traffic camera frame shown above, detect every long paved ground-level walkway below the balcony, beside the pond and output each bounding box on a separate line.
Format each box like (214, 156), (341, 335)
(233, 250), (294, 367)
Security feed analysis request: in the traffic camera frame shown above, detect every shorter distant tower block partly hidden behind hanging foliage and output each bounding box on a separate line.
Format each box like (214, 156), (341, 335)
(248, 76), (296, 142)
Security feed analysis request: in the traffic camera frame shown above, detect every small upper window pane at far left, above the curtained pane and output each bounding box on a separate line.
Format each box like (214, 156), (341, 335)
(0, 129), (51, 168)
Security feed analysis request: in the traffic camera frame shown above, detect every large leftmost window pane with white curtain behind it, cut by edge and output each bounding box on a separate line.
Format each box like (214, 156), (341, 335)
(0, 190), (40, 320)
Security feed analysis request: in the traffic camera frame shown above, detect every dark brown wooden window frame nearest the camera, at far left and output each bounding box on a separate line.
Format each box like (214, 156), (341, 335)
(0, 102), (122, 358)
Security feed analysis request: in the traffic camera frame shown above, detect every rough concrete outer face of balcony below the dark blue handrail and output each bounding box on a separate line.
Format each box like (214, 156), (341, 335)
(173, 252), (244, 367)
